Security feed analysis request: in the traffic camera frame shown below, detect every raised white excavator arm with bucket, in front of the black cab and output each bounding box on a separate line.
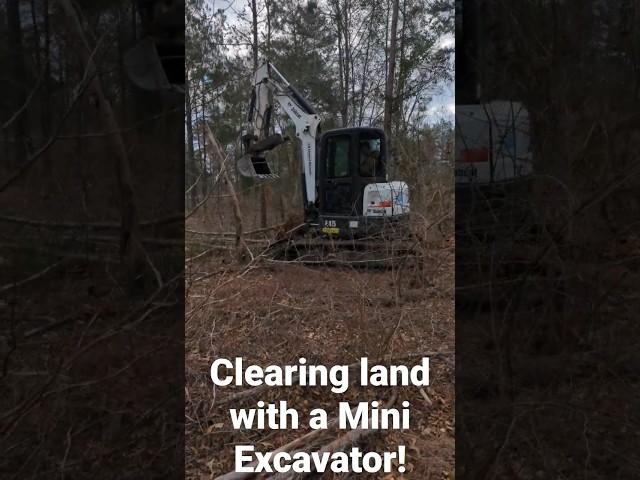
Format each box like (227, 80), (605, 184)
(238, 62), (320, 210)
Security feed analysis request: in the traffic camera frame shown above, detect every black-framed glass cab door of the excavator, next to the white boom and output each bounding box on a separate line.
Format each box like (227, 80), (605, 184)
(320, 132), (356, 215)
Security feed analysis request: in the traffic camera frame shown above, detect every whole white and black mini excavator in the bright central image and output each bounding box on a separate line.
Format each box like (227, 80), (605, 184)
(238, 62), (409, 263)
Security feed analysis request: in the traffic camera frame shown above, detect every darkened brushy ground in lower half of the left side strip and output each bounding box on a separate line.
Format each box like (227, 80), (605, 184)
(0, 246), (183, 480)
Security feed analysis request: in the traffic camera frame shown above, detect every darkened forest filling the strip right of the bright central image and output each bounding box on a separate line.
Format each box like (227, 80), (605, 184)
(455, 0), (640, 479)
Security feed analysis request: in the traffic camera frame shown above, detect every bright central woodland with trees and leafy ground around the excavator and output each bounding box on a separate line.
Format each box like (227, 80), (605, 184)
(185, 0), (454, 479)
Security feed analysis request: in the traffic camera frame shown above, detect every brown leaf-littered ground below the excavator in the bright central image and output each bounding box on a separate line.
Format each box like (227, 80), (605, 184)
(185, 242), (455, 480)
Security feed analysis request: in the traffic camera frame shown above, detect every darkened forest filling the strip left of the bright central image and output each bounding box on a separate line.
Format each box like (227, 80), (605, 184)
(0, 0), (184, 479)
